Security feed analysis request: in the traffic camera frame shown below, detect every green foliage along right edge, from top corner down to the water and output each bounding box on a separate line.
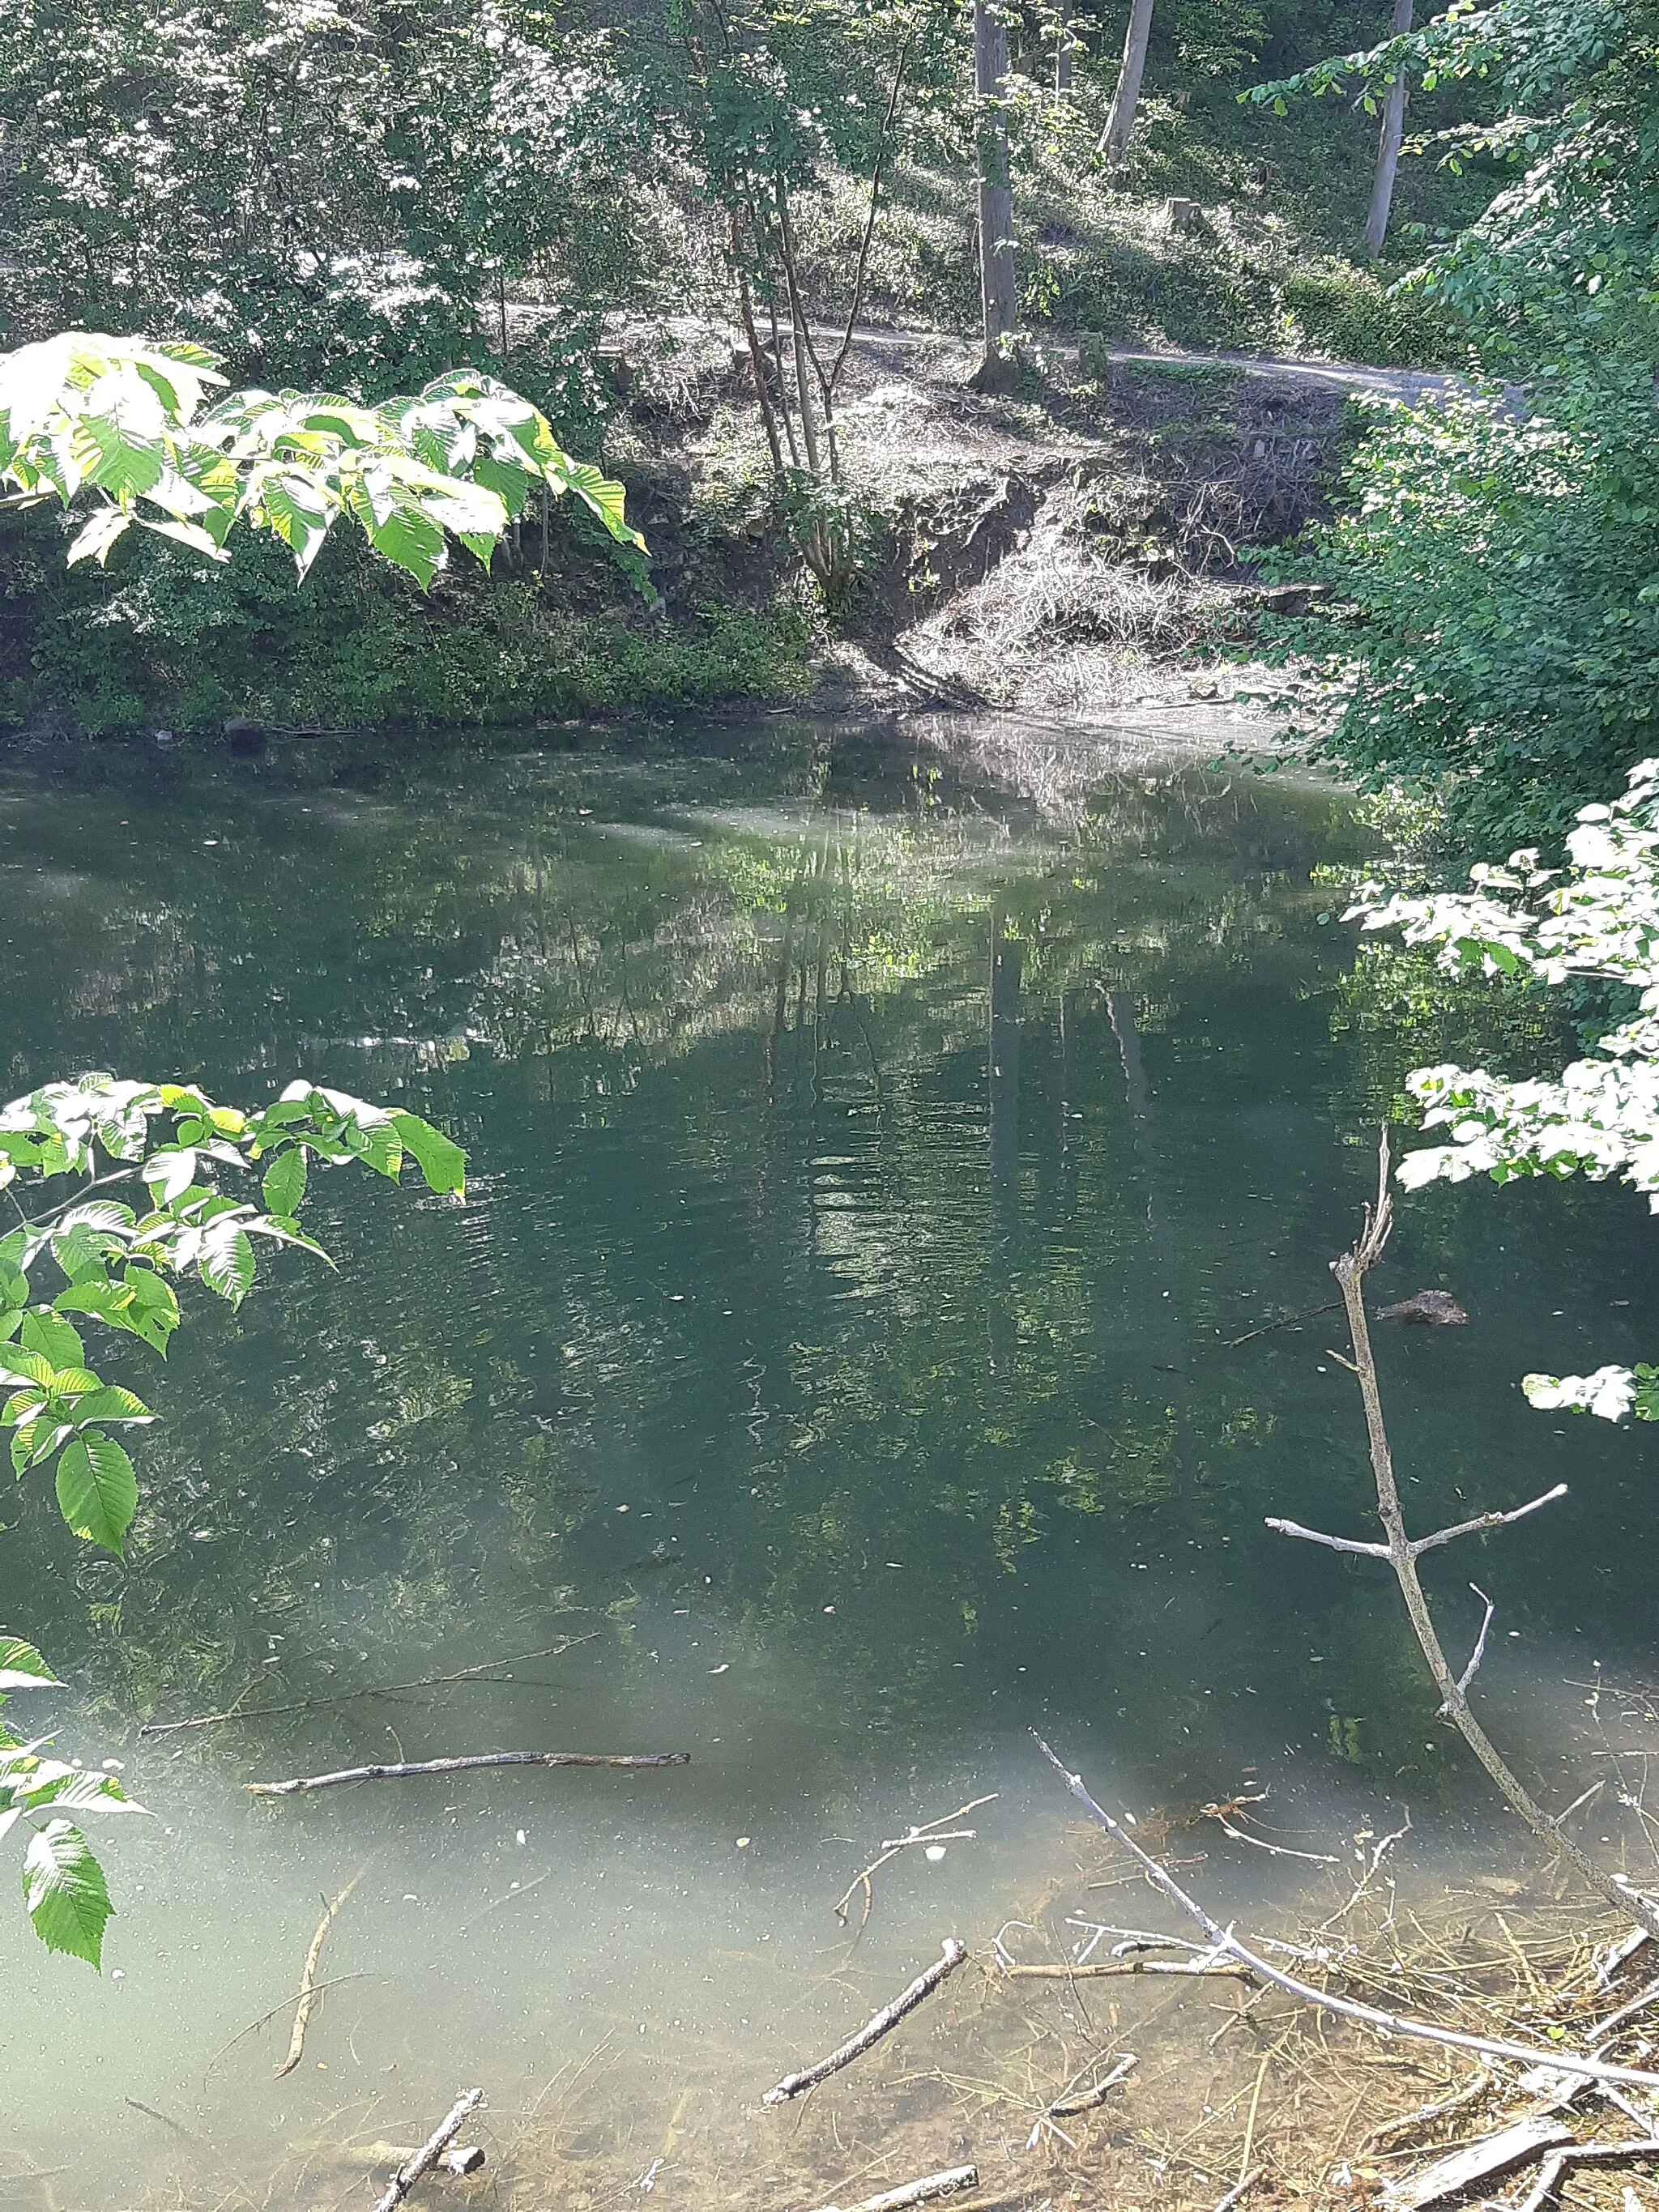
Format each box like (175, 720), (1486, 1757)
(1252, 0), (1659, 845)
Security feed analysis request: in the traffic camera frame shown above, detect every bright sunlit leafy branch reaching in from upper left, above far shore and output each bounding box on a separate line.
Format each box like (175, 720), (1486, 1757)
(0, 330), (644, 588)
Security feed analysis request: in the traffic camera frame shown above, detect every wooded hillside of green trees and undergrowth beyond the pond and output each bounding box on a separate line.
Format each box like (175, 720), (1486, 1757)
(0, 0), (1653, 847)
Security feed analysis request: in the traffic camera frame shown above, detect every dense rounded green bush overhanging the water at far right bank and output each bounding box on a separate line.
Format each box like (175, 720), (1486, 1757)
(1278, 369), (1659, 847)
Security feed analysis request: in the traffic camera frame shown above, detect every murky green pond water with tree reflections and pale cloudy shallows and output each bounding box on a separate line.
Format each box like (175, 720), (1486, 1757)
(0, 721), (1659, 2212)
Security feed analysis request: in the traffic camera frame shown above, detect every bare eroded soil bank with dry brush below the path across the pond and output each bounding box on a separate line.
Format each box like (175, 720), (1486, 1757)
(611, 323), (1380, 723)
